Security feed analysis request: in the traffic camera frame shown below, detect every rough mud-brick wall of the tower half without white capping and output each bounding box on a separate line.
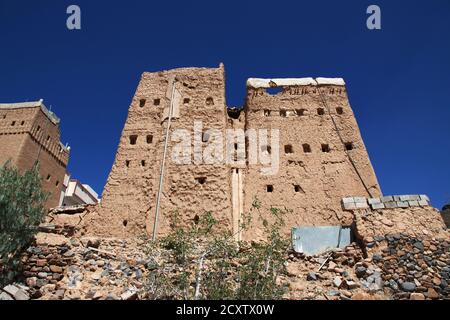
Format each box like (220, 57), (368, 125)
(86, 66), (231, 236)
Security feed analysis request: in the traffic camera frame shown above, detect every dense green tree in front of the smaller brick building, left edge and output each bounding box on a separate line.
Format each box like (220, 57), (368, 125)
(0, 162), (48, 285)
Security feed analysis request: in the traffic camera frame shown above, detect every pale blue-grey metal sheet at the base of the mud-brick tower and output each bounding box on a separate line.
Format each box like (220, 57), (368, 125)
(292, 226), (352, 255)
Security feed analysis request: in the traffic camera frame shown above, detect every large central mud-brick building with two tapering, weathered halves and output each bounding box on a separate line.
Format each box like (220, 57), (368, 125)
(87, 65), (381, 239)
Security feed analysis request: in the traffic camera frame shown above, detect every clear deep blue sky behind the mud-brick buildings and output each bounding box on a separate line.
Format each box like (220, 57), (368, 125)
(0, 0), (450, 208)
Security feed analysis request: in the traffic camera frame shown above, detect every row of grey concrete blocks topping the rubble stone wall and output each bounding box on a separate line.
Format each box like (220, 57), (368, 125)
(342, 194), (430, 210)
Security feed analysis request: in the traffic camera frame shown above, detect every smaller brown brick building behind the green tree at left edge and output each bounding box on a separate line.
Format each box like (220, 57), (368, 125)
(0, 101), (69, 208)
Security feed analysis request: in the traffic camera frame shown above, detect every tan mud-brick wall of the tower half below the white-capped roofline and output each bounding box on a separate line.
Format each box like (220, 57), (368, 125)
(244, 83), (381, 238)
